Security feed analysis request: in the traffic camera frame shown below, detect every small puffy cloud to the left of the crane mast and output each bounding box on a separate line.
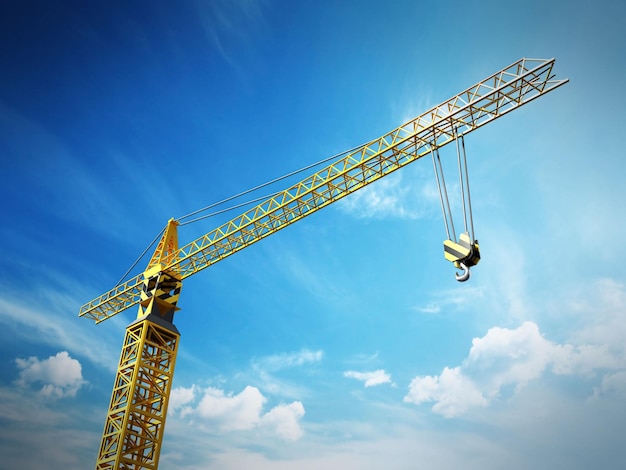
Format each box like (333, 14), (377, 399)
(15, 351), (85, 398)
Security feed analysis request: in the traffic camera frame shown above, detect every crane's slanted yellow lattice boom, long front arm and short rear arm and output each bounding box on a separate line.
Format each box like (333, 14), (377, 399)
(79, 59), (567, 322)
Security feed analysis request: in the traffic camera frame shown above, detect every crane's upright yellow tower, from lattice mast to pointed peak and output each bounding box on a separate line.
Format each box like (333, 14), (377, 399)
(96, 227), (182, 470)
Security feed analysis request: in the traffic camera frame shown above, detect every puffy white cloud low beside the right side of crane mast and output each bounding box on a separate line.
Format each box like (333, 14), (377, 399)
(171, 386), (305, 441)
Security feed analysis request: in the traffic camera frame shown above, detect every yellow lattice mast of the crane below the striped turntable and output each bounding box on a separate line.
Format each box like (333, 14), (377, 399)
(96, 315), (180, 470)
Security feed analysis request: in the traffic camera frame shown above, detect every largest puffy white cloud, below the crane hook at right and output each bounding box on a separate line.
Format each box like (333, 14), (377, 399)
(404, 322), (624, 418)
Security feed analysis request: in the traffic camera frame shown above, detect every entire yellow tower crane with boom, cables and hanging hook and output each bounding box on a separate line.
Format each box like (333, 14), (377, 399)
(79, 58), (568, 470)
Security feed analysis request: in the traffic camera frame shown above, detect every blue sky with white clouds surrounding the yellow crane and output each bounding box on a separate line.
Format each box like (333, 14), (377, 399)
(0, 0), (626, 470)
